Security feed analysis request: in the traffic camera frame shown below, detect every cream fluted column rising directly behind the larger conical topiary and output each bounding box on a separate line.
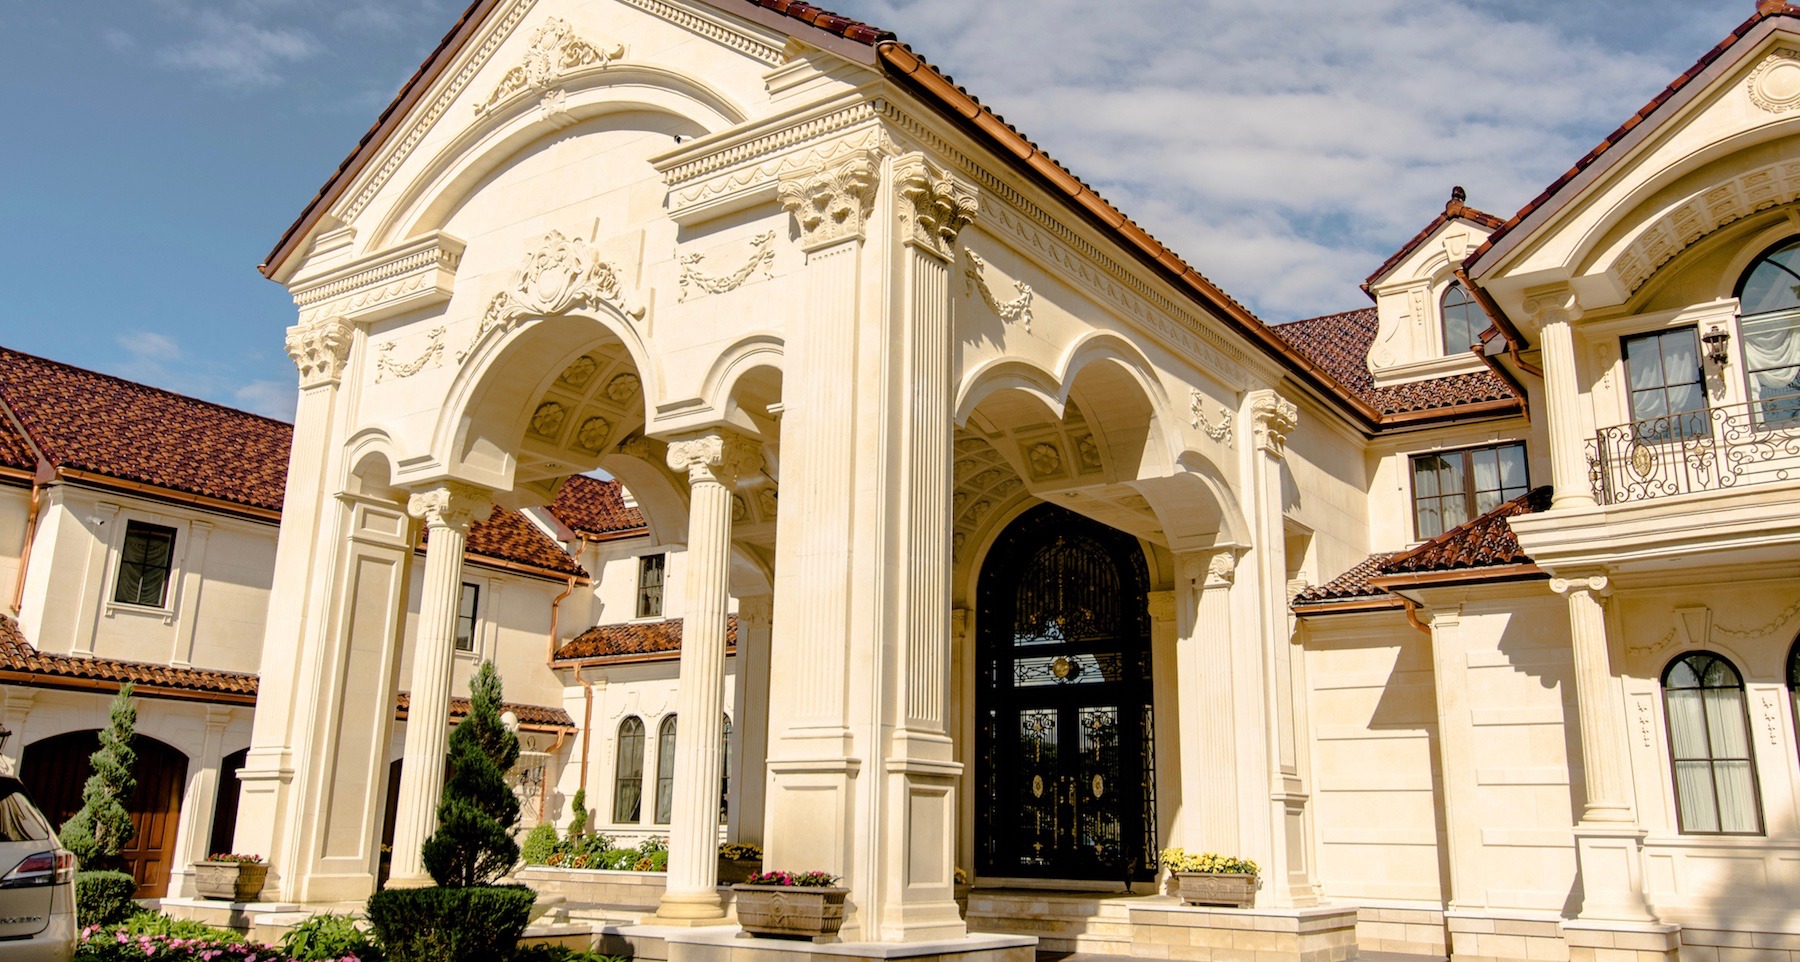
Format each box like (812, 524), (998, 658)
(387, 481), (493, 888)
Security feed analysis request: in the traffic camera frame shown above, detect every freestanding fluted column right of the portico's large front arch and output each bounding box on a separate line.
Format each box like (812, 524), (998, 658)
(657, 432), (761, 924)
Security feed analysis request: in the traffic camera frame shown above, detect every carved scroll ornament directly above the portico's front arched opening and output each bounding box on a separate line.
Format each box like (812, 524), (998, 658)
(455, 231), (644, 364)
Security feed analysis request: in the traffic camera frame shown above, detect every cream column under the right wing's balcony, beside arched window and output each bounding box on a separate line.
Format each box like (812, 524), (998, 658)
(1550, 573), (1652, 922)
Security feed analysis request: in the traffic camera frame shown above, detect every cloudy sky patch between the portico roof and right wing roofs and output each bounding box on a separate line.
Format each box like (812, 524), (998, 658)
(842, 0), (1692, 321)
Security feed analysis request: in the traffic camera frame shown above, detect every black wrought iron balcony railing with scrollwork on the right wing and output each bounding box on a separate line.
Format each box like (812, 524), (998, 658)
(1588, 396), (1800, 504)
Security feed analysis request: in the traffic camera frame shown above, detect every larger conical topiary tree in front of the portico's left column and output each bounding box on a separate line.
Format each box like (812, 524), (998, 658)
(419, 661), (518, 888)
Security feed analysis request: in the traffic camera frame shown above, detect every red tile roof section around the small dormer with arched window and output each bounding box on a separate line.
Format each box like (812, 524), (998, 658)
(1274, 308), (1521, 414)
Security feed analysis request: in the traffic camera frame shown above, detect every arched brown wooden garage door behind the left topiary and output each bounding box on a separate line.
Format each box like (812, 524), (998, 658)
(20, 730), (187, 899)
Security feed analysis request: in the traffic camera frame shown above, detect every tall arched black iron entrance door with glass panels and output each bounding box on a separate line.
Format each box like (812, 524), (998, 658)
(976, 504), (1157, 881)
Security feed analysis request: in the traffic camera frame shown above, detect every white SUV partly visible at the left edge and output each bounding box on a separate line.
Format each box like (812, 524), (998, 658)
(0, 776), (79, 962)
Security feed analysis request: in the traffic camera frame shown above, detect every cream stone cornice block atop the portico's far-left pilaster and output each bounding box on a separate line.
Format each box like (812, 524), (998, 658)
(288, 231), (466, 326)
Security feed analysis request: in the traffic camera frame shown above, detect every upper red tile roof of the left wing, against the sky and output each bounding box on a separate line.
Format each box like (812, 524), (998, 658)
(0, 348), (293, 512)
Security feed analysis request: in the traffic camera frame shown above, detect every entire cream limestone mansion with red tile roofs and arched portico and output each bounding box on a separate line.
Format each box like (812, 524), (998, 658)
(0, 0), (1800, 962)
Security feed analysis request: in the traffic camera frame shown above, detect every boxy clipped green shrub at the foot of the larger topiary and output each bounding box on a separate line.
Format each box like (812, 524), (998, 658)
(369, 885), (536, 962)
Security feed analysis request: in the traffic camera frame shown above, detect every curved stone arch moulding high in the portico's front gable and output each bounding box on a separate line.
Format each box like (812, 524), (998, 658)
(367, 71), (749, 250)
